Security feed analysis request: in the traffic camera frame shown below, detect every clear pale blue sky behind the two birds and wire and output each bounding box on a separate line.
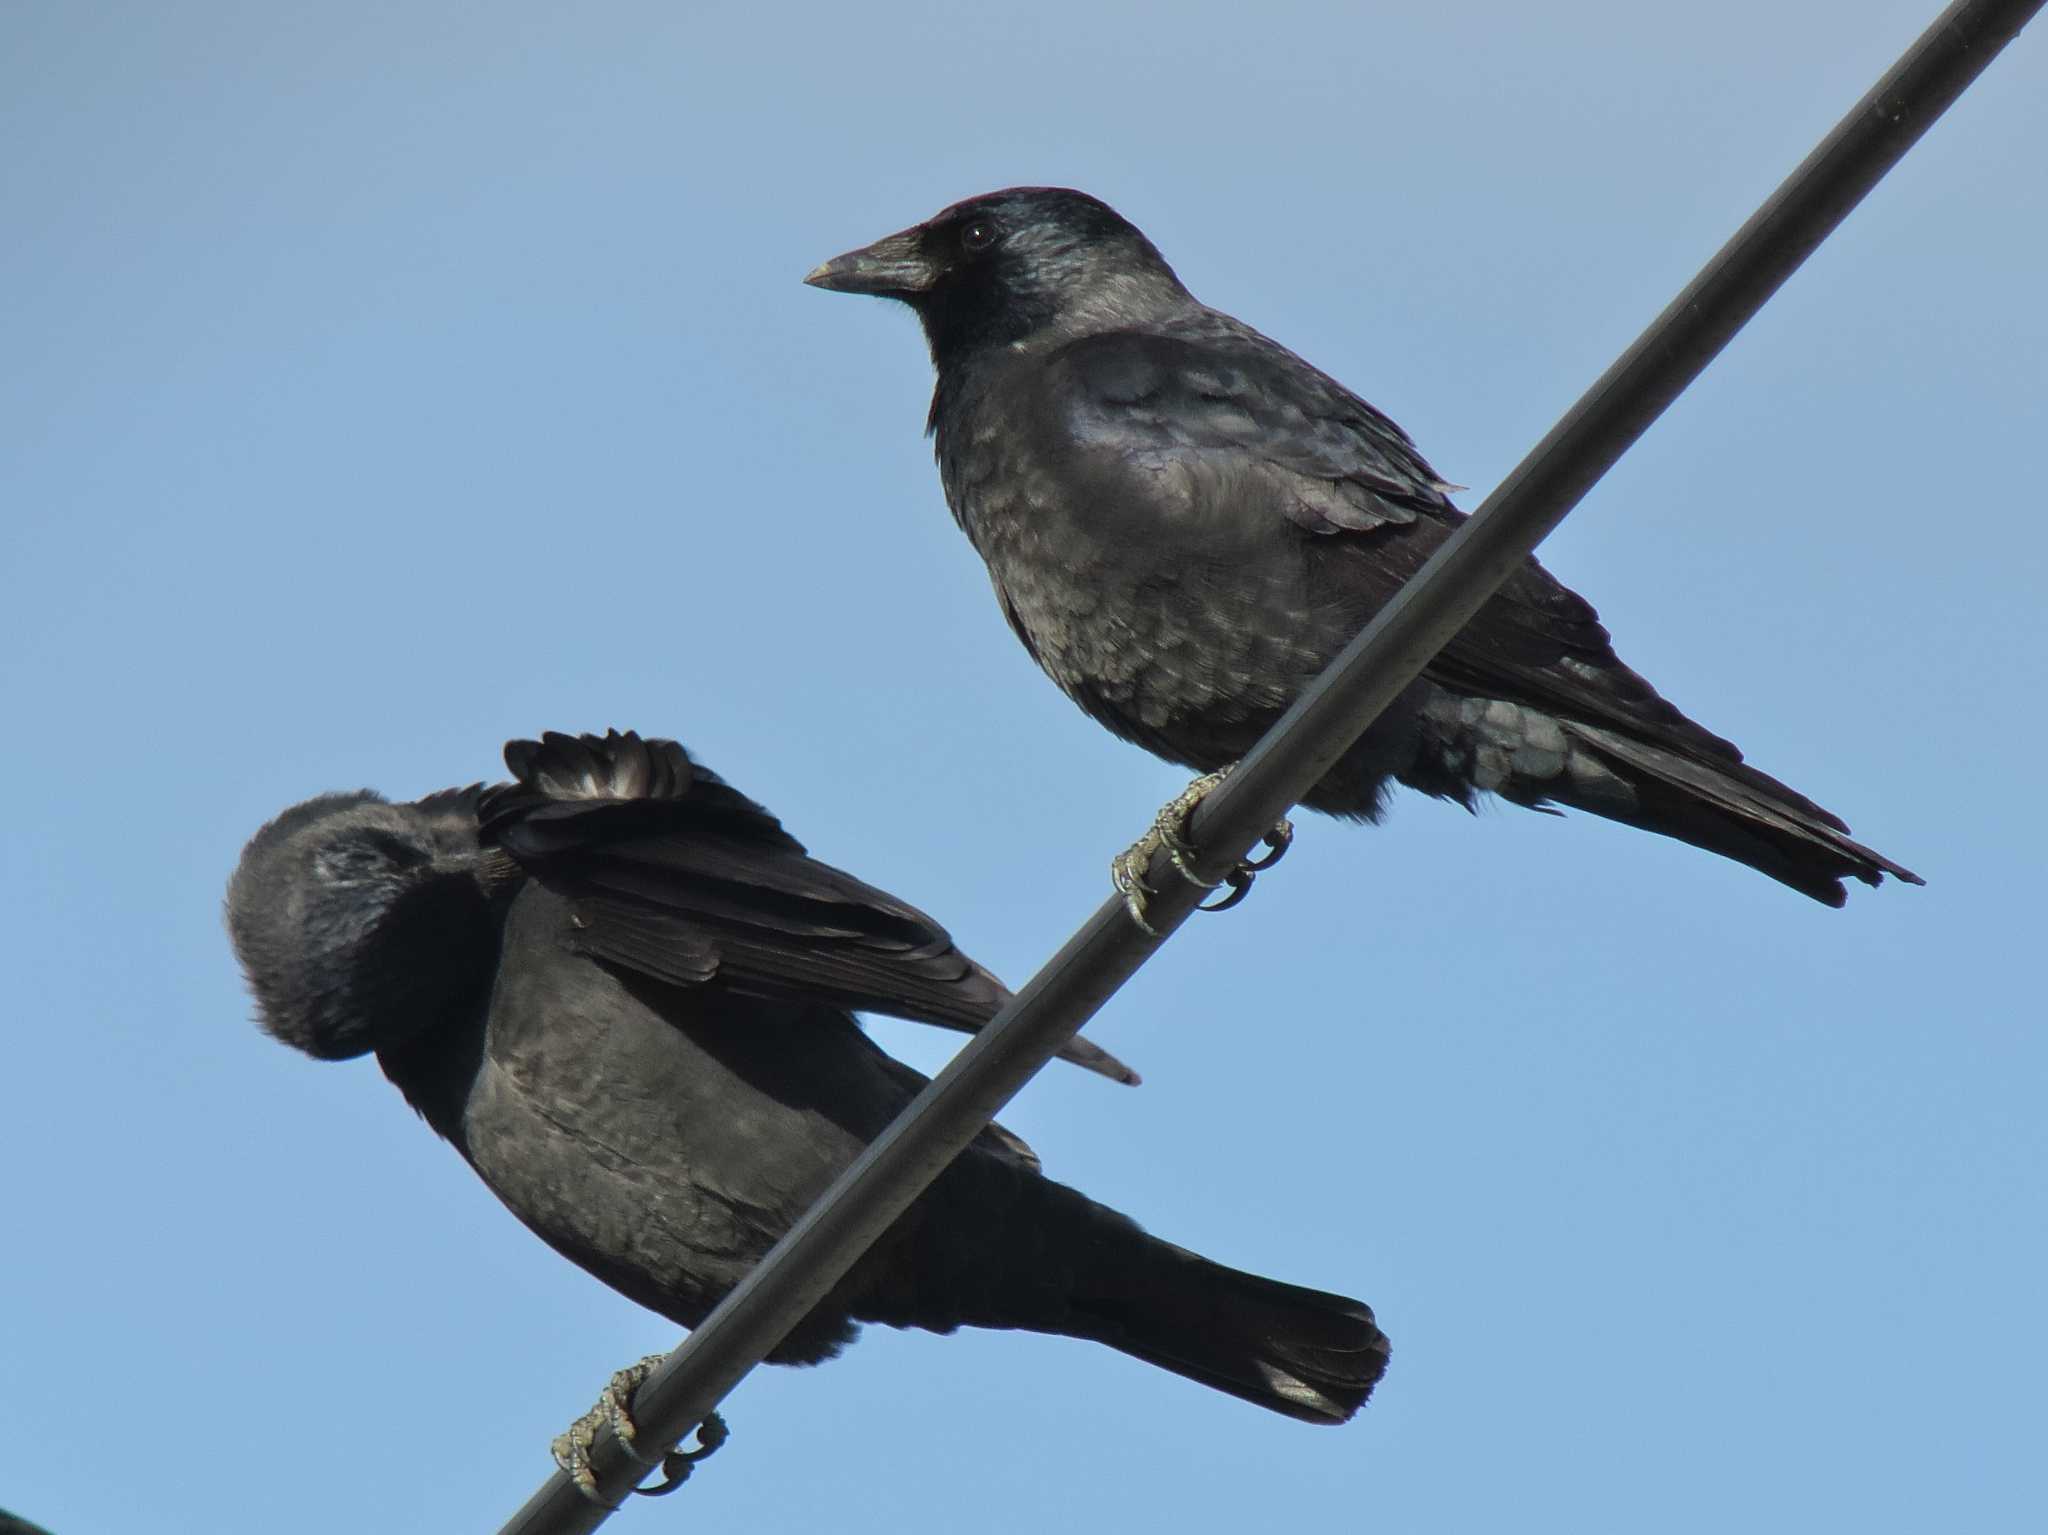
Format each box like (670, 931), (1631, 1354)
(0, 0), (2048, 1535)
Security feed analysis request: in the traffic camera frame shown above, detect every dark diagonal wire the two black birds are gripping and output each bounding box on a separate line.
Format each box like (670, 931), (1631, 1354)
(500, 0), (2048, 1535)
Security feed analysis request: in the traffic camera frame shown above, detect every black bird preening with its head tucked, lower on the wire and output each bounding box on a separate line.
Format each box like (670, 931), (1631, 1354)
(227, 733), (1386, 1449)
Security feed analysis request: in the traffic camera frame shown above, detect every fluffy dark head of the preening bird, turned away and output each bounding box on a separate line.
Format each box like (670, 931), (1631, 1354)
(227, 790), (494, 1060)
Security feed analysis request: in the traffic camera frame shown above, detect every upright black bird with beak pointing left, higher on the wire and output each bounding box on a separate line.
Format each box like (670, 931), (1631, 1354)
(807, 186), (1921, 907)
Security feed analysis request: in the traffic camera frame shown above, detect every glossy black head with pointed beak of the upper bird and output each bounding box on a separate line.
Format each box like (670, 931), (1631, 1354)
(805, 186), (1194, 366)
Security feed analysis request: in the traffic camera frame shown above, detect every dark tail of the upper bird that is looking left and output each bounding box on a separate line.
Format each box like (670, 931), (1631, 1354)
(1542, 720), (1925, 907)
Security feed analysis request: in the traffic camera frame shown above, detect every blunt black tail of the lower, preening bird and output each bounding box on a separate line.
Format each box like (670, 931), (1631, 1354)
(1061, 1236), (1386, 1422)
